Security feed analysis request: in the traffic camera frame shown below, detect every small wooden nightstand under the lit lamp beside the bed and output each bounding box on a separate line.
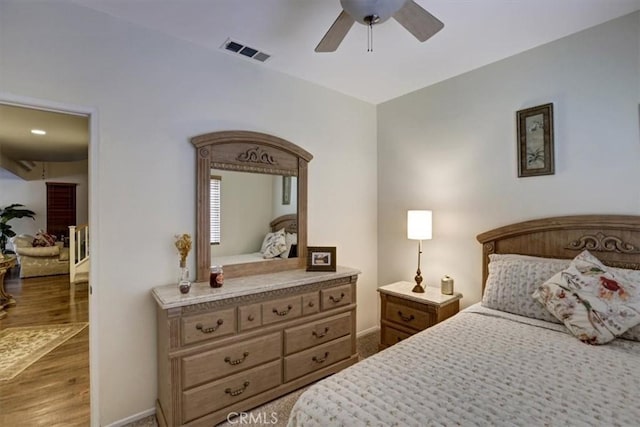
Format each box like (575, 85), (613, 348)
(378, 282), (462, 350)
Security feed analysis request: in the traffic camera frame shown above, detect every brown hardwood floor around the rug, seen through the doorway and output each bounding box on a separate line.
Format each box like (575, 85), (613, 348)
(0, 268), (90, 427)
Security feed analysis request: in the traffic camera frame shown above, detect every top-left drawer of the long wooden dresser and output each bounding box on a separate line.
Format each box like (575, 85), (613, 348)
(182, 308), (236, 345)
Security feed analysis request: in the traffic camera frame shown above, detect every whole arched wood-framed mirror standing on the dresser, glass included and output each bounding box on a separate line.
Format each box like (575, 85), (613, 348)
(191, 131), (313, 281)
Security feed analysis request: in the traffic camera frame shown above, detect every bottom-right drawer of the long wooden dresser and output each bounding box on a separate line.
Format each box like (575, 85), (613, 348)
(284, 336), (351, 382)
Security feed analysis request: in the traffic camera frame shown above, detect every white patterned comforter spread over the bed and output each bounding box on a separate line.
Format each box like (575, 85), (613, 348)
(288, 304), (640, 427)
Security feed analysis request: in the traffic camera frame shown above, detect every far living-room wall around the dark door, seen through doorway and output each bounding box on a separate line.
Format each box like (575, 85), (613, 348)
(0, 161), (89, 247)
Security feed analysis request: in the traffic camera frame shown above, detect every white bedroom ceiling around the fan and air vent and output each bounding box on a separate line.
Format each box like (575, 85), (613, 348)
(73, 0), (640, 104)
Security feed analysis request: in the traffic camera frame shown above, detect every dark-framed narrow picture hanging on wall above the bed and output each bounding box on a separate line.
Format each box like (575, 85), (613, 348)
(516, 103), (555, 177)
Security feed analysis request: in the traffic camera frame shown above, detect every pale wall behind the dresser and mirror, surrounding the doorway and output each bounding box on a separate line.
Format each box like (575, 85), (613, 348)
(0, 0), (378, 425)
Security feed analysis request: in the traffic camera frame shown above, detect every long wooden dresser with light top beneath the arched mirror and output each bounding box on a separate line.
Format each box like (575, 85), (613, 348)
(153, 267), (359, 427)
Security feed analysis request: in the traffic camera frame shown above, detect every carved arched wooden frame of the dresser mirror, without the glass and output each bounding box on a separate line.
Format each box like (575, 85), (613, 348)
(191, 130), (313, 282)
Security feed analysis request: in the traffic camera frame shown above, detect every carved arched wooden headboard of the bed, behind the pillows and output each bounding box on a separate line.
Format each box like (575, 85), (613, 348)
(477, 215), (640, 290)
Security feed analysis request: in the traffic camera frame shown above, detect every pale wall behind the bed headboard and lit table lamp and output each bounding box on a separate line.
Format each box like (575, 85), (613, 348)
(378, 13), (640, 306)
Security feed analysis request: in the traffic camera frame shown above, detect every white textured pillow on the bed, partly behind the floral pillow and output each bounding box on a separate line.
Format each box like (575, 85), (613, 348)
(482, 254), (571, 323)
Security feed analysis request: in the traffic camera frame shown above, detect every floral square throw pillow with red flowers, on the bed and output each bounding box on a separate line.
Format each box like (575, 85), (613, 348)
(532, 251), (640, 344)
